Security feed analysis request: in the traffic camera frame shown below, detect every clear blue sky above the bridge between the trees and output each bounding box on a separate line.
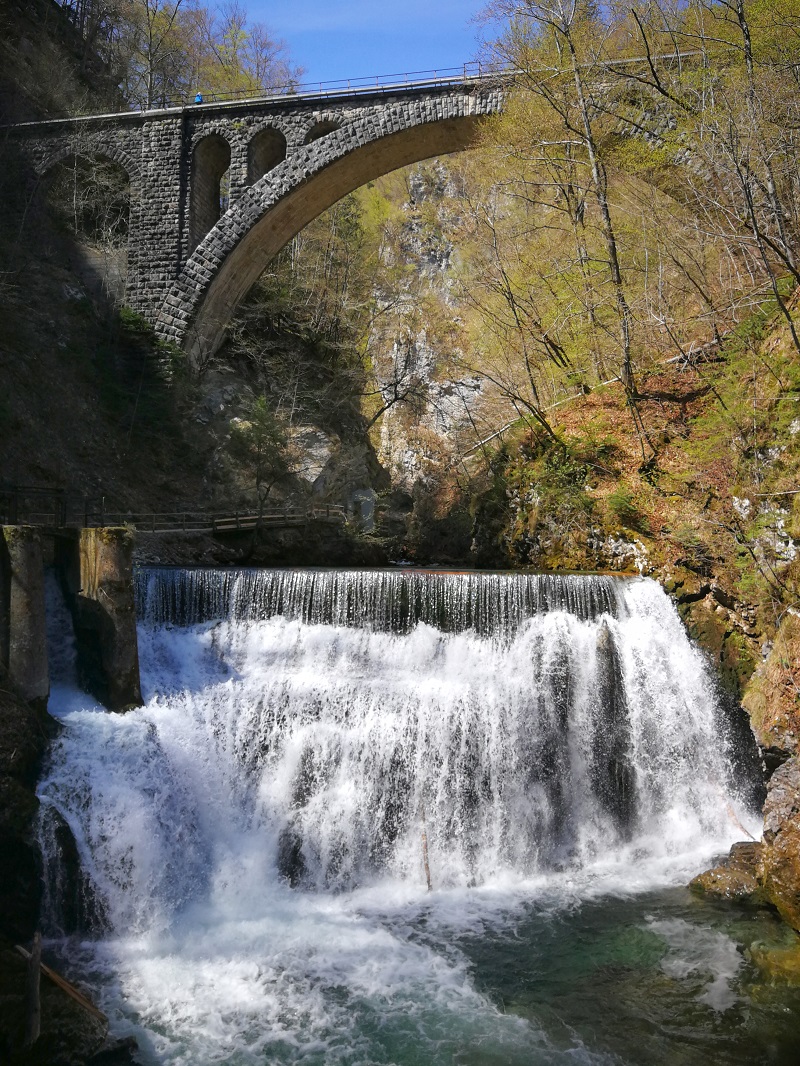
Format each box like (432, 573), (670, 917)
(244, 0), (501, 81)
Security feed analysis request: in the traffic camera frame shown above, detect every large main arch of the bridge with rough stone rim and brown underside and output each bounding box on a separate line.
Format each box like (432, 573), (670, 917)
(156, 99), (499, 366)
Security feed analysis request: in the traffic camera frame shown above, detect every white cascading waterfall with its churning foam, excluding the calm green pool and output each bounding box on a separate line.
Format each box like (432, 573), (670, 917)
(41, 570), (763, 1063)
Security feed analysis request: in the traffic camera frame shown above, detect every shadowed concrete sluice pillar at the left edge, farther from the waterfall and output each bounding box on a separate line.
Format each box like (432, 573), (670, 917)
(0, 526), (50, 710)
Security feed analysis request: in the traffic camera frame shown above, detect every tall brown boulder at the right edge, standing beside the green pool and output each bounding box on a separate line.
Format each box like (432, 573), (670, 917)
(758, 757), (800, 931)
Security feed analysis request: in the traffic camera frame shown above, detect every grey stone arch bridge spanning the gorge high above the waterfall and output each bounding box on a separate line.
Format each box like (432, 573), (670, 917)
(4, 76), (505, 364)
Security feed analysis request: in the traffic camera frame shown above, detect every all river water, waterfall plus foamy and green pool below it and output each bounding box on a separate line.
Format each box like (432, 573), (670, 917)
(39, 570), (800, 1066)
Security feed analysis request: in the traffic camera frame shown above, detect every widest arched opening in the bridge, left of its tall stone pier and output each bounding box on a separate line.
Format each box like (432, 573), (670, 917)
(42, 154), (131, 303)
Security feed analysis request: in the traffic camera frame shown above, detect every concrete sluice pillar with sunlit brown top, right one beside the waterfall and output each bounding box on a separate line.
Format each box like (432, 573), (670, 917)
(57, 528), (142, 711)
